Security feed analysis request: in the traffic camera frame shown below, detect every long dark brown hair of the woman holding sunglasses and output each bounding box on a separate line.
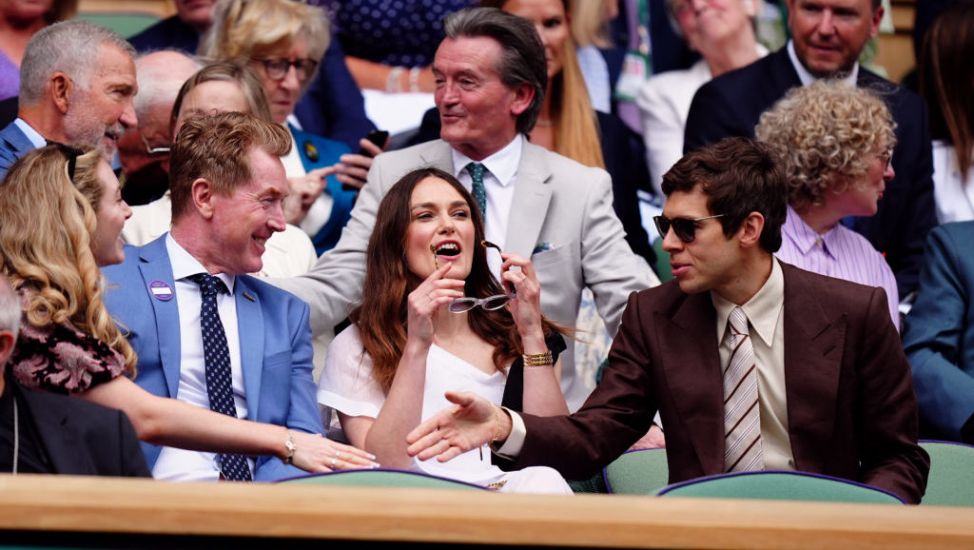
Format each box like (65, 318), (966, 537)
(349, 168), (562, 392)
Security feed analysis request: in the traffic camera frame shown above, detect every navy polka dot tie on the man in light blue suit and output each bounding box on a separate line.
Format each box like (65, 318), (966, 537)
(189, 273), (253, 481)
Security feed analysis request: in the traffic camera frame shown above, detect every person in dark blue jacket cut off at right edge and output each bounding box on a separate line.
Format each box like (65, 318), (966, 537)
(903, 222), (974, 443)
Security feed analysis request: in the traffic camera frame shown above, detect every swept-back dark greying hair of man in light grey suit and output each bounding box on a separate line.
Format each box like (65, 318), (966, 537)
(443, 8), (548, 134)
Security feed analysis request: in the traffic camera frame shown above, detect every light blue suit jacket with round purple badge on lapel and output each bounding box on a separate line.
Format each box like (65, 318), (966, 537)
(103, 235), (323, 481)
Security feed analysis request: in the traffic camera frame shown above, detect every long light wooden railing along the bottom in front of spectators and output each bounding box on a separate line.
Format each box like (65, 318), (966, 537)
(0, 475), (974, 549)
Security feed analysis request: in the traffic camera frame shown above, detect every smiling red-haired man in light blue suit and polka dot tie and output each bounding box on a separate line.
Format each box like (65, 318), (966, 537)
(105, 113), (324, 481)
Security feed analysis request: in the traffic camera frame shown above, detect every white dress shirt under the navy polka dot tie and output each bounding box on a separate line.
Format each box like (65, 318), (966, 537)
(152, 235), (254, 481)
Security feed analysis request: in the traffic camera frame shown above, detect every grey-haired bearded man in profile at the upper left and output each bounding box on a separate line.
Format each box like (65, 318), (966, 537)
(0, 20), (138, 178)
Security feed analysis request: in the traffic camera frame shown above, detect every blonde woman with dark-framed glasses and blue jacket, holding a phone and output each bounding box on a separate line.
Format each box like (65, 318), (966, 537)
(199, 0), (360, 254)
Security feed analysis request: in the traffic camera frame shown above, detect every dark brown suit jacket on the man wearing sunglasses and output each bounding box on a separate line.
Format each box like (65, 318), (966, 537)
(516, 264), (930, 502)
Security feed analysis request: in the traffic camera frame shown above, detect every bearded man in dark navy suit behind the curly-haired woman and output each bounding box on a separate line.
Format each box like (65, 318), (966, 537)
(684, 0), (936, 300)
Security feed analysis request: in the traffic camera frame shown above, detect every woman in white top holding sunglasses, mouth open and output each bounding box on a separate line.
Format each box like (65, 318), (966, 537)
(318, 168), (571, 494)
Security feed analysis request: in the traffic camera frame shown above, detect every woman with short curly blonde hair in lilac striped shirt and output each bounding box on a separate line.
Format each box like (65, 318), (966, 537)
(756, 81), (900, 327)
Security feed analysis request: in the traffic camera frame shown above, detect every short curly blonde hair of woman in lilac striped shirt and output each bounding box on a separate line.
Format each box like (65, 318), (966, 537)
(755, 81), (896, 210)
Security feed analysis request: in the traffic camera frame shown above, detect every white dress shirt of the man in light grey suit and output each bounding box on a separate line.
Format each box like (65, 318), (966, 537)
(452, 134), (524, 276)
